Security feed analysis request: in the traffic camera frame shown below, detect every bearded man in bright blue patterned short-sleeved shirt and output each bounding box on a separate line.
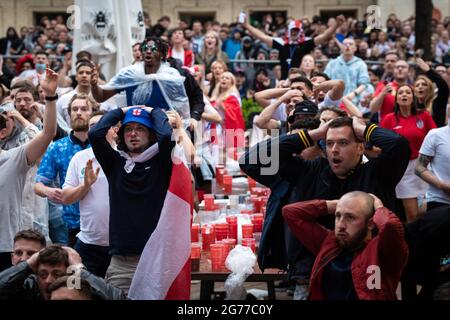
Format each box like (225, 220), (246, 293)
(35, 94), (97, 246)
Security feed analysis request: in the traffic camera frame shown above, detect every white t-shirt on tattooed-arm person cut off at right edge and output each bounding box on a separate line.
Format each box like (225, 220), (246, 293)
(419, 126), (450, 204)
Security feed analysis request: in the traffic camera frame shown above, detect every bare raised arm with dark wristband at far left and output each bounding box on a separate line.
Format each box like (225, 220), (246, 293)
(25, 68), (58, 164)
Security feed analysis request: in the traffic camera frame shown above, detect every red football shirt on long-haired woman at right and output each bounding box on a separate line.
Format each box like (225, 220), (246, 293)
(381, 111), (436, 160)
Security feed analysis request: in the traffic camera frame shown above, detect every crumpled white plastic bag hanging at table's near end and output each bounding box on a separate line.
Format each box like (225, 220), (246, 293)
(225, 245), (256, 300)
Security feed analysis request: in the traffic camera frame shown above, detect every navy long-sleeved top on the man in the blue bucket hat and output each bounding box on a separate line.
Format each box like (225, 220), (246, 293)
(89, 109), (175, 255)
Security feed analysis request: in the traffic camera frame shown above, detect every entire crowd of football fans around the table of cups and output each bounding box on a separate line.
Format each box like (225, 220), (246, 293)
(0, 10), (450, 300)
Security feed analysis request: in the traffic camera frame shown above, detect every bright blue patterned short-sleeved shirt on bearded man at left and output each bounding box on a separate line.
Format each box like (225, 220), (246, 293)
(36, 132), (89, 229)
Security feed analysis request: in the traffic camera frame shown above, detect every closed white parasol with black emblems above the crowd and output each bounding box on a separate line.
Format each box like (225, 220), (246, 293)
(73, 0), (145, 79)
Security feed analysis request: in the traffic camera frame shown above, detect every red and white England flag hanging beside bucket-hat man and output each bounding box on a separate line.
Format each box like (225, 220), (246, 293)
(128, 145), (193, 300)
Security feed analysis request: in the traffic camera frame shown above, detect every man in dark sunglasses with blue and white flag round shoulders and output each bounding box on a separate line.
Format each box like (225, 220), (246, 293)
(91, 37), (204, 131)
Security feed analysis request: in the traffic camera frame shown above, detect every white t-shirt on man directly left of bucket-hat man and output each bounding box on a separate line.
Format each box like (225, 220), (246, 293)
(63, 148), (109, 246)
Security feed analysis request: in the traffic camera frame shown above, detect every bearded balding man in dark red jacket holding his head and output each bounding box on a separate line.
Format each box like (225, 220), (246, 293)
(283, 191), (409, 300)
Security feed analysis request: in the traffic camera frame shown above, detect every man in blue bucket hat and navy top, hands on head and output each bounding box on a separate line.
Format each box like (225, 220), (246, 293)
(89, 106), (175, 292)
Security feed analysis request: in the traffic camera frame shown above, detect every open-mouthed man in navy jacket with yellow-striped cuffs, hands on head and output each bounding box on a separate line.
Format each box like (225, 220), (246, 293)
(240, 117), (410, 209)
